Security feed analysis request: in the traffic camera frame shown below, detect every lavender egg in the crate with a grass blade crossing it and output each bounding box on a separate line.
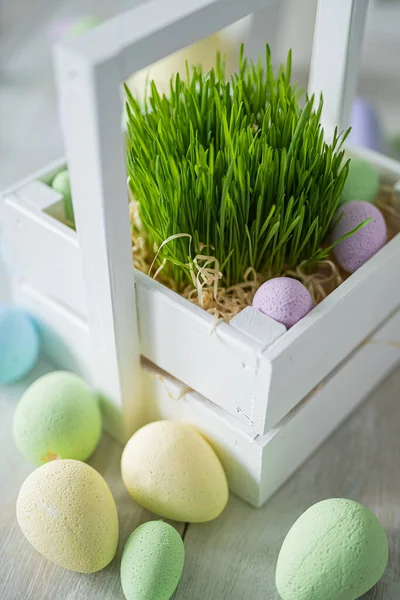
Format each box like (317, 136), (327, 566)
(332, 201), (387, 273)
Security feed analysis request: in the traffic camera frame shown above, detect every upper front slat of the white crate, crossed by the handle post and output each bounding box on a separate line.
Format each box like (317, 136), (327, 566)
(4, 195), (269, 428)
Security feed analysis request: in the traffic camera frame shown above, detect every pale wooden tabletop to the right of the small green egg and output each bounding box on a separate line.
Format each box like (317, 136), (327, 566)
(175, 371), (400, 600)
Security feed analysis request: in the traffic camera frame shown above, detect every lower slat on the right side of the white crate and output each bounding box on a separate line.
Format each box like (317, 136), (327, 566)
(257, 304), (400, 506)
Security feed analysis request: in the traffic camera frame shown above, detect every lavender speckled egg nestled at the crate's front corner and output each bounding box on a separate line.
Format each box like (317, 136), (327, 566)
(253, 277), (314, 328)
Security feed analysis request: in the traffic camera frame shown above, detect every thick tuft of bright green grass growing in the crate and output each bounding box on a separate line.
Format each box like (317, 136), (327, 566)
(125, 45), (348, 287)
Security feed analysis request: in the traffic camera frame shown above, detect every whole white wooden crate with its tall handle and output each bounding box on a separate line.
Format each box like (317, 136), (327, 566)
(2, 0), (400, 505)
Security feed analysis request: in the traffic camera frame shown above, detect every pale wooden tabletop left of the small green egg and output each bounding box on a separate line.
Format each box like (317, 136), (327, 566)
(0, 361), (184, 600)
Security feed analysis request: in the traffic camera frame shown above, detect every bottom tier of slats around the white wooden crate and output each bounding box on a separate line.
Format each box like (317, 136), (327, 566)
(10, 274), (400, 506)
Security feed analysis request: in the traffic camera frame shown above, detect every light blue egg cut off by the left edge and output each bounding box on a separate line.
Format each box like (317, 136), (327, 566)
(0, 305), (40, 385)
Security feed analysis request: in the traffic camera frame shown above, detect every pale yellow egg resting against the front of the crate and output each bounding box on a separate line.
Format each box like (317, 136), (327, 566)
(121, 421), (228, 523)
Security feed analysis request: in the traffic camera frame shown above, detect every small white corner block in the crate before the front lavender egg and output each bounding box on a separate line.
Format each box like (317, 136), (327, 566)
(229, 306), (286, 349)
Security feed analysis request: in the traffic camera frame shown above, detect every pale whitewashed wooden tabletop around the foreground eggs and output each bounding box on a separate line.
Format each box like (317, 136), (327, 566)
(0, 350), (400, 600)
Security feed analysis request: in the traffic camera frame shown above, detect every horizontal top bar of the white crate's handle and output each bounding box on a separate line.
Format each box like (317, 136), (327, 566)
(58, 0), (278, 77)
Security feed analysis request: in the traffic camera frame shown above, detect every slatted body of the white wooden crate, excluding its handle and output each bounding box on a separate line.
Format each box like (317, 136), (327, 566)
(3, 145), (400, 506)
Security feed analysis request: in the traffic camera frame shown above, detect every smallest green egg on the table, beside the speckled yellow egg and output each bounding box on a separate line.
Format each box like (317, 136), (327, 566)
(121, 521), (185, 600)
